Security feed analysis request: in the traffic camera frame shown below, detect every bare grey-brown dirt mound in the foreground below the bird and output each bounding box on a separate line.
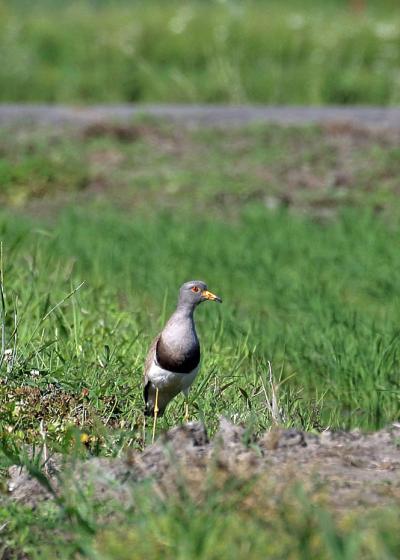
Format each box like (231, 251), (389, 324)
(8, 418), (400, 512)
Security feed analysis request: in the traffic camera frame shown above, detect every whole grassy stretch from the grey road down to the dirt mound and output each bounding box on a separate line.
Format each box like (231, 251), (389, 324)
(0, 122), (400, 434)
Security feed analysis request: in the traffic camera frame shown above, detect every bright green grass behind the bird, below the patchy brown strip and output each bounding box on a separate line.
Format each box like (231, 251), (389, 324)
(2, 206), (400, 444)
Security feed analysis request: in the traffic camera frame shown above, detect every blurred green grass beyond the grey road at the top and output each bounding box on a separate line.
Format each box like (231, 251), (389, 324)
(0, 0), (400, 105)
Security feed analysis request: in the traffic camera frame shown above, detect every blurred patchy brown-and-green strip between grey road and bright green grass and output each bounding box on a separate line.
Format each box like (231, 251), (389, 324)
(0, 115), (400, 217)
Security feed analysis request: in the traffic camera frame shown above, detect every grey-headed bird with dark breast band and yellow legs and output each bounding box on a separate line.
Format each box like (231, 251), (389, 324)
(143, 280), (222, 442)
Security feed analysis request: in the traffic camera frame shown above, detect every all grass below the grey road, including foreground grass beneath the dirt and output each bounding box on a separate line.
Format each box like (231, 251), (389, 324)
(0, 120), (400, 559)
